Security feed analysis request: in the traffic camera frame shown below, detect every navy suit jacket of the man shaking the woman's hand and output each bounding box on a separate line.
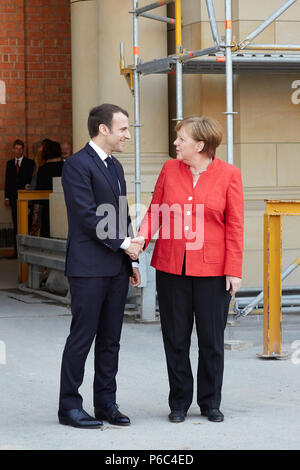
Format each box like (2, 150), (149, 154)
(62, 144), (132, 277)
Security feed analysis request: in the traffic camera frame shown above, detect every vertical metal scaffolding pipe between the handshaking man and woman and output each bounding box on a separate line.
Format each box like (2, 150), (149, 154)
(133, 0), (141, 228)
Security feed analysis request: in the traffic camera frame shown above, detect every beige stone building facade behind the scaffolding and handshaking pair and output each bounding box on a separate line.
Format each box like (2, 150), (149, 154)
(10, 0), (300, 287)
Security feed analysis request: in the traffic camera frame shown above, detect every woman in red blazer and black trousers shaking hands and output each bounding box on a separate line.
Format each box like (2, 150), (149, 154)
(139, 116), (244, 423)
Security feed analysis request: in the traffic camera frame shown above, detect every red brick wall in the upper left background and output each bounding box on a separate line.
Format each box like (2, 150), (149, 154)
(0, 0), (72, 189)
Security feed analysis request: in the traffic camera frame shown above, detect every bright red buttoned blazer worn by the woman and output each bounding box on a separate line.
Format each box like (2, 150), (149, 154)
(139, 158), (244, 278)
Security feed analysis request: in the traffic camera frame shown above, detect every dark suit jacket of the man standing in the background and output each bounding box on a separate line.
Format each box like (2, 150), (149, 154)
(5, 157), (35, 200)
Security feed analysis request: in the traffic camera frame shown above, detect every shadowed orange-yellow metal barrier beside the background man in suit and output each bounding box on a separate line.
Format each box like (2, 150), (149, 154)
(17, 190), (52, 282)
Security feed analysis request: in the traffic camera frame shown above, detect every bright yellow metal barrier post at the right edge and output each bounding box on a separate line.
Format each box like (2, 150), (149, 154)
(259, 201), (300, 359)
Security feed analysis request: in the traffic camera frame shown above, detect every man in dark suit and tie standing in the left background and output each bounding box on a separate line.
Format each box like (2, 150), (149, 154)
(4, 139), (34, 258)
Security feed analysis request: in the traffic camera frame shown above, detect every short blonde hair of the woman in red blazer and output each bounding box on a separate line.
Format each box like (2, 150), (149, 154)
(175, 116), (223, 156)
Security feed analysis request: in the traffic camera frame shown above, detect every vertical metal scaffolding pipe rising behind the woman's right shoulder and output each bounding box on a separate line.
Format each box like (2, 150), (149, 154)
(225, 0), (234, 164)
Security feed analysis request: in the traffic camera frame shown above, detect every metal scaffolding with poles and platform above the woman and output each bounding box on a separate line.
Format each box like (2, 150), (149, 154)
(120, 0), (300, 226)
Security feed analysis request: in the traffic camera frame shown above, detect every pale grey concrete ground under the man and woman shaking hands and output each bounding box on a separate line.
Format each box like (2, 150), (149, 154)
(0, 260), (300, 451)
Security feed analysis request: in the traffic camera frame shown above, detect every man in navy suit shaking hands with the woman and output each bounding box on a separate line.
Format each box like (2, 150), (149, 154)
(58, 104), (142, 428)
